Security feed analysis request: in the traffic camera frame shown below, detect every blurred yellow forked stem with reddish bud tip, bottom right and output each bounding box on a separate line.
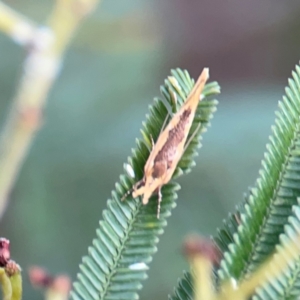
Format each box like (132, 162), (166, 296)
(184, 235), (300, 300)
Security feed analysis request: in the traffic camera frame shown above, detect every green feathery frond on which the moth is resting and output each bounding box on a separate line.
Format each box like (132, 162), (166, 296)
(71, 69), (219, 300)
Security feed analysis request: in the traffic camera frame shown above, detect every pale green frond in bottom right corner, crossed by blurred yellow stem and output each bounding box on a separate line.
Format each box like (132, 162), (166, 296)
(253, 204), (300, 300)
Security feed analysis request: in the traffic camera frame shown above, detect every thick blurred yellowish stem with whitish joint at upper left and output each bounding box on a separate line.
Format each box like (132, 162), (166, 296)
(0, 0), (99, 217)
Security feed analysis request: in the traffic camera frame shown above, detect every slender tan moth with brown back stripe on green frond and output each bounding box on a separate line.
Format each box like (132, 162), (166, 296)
(121, 68), (209, 218)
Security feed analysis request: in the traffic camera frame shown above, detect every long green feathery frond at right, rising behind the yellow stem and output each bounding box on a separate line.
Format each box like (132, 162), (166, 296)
(218, 66), (300, 280)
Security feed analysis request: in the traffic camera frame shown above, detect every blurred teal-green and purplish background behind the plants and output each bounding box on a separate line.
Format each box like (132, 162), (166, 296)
(0, 0), (300, 300)
